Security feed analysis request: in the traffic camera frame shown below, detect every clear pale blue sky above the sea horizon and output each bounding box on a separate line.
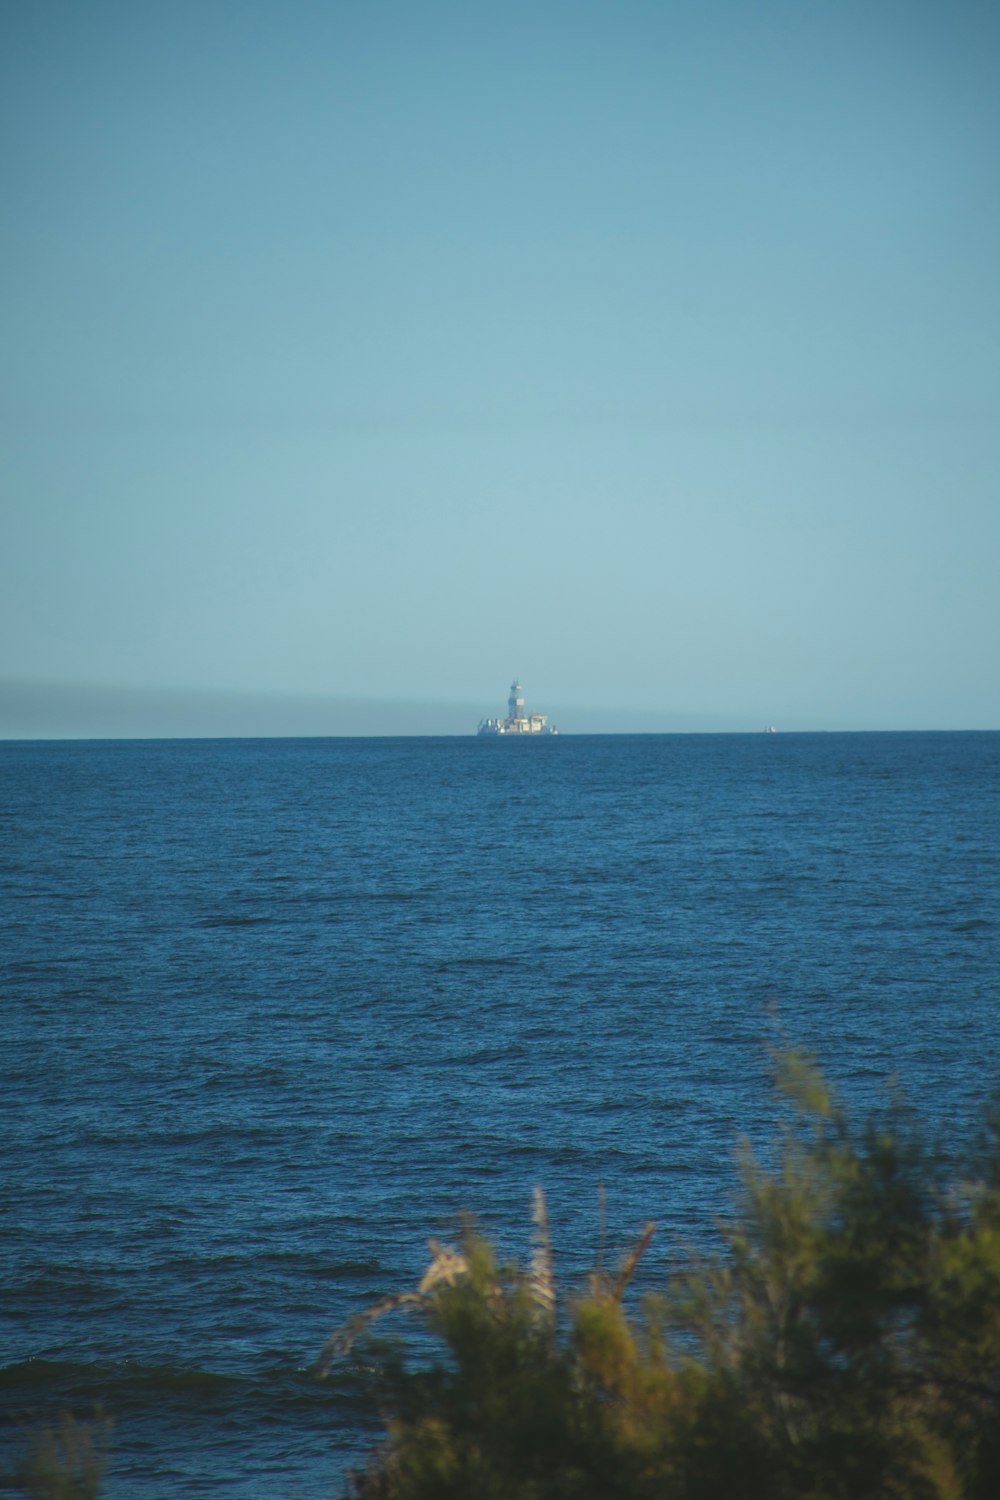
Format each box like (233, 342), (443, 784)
(0, 0), (1000, 737)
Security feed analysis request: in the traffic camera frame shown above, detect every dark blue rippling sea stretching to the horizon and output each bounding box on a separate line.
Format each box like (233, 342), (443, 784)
(0, 734), (1000, 1500)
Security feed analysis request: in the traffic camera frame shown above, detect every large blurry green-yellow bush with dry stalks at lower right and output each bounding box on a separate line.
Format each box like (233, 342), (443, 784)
(319, 1056), (1000, 1500)
